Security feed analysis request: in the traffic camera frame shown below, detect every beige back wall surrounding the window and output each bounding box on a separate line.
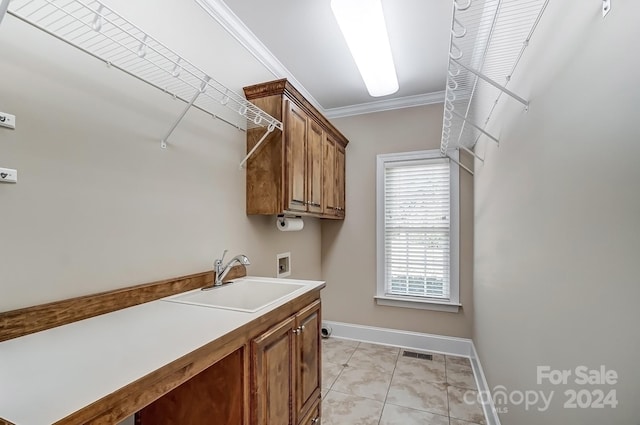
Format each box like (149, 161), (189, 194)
(322, 105), (473, 337)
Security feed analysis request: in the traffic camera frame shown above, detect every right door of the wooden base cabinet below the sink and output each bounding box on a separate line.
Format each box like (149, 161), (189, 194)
(296, 301), (321, 420)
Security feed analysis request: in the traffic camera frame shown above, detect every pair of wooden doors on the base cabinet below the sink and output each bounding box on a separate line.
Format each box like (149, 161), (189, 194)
(251, 301), (321, 425)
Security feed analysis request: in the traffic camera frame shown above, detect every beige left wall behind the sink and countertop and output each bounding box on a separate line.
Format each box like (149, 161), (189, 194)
(0, 2), (321, 311)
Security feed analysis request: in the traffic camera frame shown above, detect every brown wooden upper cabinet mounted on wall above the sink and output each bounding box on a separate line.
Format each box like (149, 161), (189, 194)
(244, 80), (349, 219)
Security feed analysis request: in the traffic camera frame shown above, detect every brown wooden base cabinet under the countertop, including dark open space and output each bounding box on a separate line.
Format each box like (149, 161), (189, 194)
(136, 291), (321, 425)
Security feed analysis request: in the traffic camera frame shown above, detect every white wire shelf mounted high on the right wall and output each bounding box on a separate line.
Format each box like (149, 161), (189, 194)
(440, 0), (549, 174)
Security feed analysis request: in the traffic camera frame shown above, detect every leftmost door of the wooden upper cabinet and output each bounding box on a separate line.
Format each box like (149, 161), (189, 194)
(284, 100), (308, 211)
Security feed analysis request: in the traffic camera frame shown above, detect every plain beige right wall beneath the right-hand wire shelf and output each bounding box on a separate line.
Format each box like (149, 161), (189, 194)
(473, 0), (640, 425)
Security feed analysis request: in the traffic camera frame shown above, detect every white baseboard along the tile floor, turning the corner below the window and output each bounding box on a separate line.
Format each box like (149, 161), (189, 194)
(322, 321), (500, 425)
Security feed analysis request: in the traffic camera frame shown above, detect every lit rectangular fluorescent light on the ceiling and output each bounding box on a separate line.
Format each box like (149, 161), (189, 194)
(331, 0), (398, 97)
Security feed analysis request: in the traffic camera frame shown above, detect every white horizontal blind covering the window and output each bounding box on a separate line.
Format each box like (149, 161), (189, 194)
(384, 159), (451, 300)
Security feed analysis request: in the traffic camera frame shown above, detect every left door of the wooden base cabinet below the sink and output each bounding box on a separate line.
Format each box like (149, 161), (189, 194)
(251, 317), (296, 425)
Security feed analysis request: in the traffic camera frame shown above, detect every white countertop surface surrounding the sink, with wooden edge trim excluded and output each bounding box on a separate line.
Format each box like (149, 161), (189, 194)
(0, 278), (324, 425)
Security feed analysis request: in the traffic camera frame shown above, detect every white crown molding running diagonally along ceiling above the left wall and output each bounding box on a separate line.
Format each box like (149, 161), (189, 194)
(196, 0), (324, 114)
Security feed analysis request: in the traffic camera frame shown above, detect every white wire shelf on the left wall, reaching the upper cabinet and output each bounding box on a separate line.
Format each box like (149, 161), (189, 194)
(0, 0), (283, 157)
